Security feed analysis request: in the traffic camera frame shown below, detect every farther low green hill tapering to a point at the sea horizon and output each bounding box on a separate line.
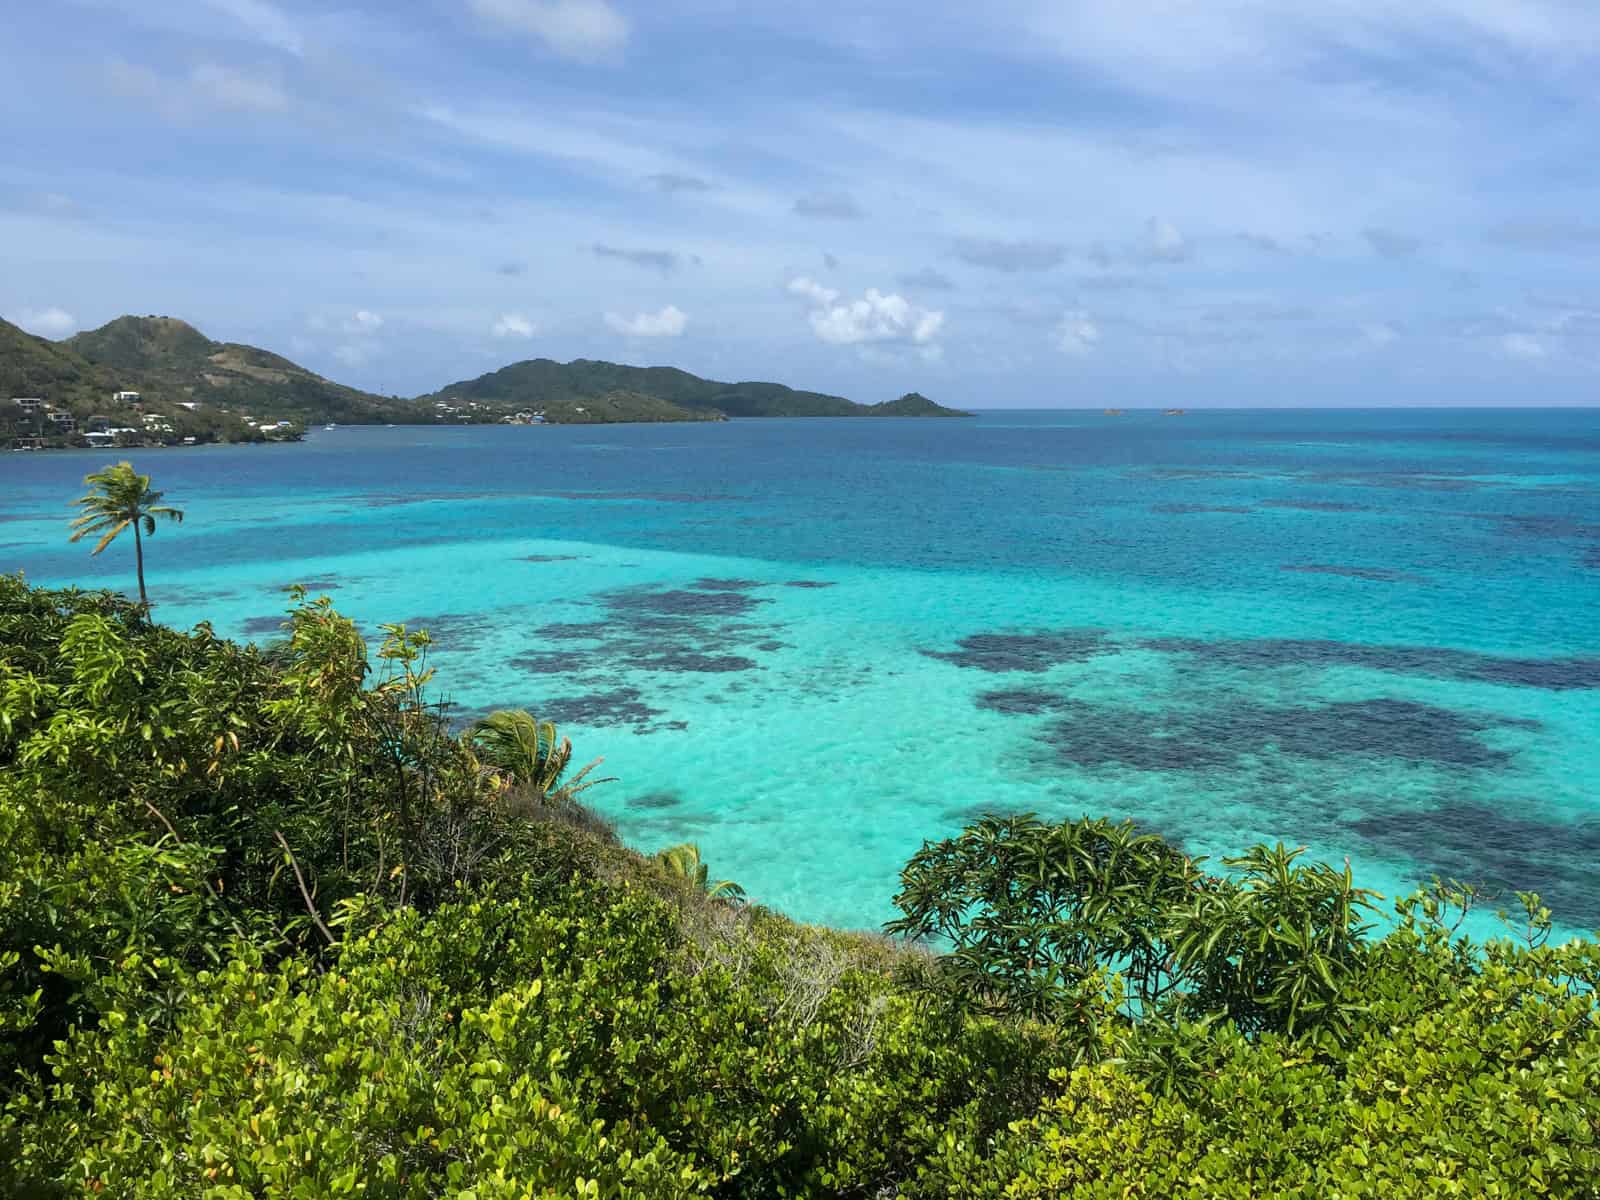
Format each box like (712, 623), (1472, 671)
(422, 358), (957, 416)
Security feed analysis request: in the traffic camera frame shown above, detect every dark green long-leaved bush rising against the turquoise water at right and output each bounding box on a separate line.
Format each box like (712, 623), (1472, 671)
(888, 816), (1374, 1042)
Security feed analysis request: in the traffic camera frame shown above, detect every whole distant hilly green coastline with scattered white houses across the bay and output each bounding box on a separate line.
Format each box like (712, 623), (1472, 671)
(0, 317), (971, 450)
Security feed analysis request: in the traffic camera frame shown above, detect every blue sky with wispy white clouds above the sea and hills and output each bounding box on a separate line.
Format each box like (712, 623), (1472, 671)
(0, 0), (1600, 406)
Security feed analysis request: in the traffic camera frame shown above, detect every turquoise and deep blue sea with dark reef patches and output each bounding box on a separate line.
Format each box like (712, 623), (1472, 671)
(0, 410), (1600, 928)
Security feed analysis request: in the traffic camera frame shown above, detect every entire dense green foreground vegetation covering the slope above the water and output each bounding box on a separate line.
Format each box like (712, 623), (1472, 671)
(0, 578), (1600, 1200)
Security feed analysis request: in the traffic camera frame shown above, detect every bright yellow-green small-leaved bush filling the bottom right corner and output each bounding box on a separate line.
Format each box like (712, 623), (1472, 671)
(928, 944), (1600, 1200)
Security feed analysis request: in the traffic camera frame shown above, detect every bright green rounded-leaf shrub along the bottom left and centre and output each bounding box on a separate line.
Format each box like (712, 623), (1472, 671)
(3, 883), (1062, 1197)
